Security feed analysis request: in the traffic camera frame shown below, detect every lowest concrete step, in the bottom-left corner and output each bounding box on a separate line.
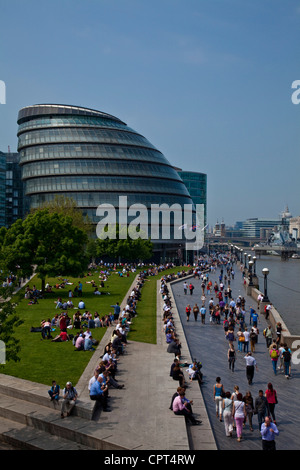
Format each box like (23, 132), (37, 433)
(0, 418), (91, 450)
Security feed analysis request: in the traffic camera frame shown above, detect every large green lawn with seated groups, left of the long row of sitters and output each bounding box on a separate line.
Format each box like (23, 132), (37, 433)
(0, 272), (135, 385)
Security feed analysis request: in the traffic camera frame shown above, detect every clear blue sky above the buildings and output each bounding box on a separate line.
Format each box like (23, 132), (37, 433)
(0, 0), (300, 225)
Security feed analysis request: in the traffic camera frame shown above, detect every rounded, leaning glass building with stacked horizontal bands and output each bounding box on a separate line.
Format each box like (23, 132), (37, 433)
(18, 104), (192, 258)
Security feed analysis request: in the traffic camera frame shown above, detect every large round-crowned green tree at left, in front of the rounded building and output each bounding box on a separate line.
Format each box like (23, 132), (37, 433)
(1, 209), (88, 290)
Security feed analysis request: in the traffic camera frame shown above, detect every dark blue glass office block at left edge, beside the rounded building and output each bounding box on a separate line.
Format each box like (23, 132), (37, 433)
(0, 152), (24, 227)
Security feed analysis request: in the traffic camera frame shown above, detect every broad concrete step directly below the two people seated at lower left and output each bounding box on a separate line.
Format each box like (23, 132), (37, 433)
(0, 395), (126, 450)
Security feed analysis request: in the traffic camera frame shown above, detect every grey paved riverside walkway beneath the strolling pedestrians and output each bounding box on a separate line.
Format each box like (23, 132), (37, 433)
(172, 265), (300, 450)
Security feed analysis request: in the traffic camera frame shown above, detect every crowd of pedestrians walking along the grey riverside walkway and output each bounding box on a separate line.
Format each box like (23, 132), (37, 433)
(178, 256), (291, 450)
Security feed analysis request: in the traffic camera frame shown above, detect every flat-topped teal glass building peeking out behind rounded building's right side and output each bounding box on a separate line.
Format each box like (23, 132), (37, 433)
(177, 169), (207, 225)
